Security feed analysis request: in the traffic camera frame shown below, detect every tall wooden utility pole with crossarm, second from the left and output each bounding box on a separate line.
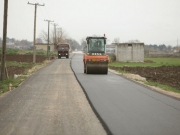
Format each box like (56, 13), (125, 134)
(28, 2), (44, 63)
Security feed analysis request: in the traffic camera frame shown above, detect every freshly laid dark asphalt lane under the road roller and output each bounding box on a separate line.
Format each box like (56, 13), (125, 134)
(71, 54), (180, 135)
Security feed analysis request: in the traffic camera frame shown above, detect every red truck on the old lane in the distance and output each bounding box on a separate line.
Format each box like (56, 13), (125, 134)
(57, 43), (70, 59)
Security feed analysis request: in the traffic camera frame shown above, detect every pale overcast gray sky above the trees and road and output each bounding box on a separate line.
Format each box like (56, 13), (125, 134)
(0, 0), (180, 46)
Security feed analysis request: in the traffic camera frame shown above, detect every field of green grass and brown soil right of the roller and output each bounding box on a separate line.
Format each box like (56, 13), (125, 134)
(109, 58), (180, 93)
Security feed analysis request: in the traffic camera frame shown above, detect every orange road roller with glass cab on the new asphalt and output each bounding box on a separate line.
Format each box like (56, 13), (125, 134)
(83, 35), (109, 74)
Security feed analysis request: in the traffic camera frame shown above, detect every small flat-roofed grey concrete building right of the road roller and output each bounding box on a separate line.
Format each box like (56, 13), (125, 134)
(115, 43), (144, 62)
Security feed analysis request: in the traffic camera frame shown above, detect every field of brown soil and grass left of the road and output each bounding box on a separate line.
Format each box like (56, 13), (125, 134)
(0, 54), (54, 94)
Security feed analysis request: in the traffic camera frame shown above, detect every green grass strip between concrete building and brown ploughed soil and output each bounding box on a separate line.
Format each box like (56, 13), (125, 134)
(109, 58), (180, 67)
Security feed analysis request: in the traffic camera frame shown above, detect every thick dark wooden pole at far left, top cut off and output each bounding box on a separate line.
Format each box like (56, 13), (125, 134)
(1, 0), (8, 81)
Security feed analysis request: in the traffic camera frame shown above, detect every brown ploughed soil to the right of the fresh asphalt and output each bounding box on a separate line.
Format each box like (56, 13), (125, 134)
(109, 66), (180, 90)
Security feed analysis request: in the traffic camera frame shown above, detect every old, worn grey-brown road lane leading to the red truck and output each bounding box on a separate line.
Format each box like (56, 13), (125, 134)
(0, 53), (106, 135)
